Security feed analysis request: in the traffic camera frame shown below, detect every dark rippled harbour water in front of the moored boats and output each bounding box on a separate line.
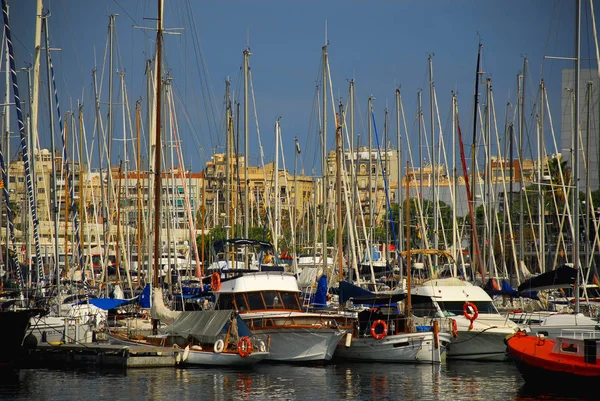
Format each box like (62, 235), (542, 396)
(0, 362), (582, 401)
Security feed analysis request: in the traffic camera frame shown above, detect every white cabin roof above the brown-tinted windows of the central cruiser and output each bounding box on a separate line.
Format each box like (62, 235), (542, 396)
(215, 272), (300, 294)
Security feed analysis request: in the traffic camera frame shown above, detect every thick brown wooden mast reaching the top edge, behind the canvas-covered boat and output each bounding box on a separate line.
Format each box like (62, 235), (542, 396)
(152, 0), (163, 333)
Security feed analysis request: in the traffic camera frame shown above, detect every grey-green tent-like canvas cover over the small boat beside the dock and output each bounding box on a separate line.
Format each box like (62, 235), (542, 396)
(164, 310), (242, 343)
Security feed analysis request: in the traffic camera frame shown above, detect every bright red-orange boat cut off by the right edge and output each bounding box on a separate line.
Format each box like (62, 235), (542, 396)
(507, 330), (600, 389)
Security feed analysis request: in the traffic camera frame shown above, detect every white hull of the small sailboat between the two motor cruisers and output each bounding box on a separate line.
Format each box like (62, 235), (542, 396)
(335, 332), (451, 364)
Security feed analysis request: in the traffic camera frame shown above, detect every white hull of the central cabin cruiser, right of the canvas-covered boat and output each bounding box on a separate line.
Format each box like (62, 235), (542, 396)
(255, 328), (346, 362)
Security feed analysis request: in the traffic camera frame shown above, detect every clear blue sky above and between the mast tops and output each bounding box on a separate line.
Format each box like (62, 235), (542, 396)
(1, 0), (600, 174)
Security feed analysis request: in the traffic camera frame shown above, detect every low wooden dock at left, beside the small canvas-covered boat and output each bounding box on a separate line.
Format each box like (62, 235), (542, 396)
(22, 343), (179, 369)
